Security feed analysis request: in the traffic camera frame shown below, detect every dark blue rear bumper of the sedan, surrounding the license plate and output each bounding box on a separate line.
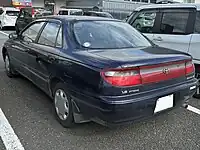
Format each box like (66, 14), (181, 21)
(73, 79), (197, 126)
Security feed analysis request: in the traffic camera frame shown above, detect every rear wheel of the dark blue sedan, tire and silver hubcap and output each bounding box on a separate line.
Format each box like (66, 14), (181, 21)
(53, 83), (74, 128)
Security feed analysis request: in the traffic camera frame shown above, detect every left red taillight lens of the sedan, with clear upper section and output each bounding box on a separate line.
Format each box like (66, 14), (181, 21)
(101, 69), (141, 86)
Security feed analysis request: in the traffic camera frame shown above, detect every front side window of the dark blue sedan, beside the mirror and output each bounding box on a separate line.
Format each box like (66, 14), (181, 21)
(22, 22), (45, 41)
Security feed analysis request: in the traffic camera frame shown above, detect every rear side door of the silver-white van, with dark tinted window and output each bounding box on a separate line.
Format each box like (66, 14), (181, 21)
(152, 8), (195, 52)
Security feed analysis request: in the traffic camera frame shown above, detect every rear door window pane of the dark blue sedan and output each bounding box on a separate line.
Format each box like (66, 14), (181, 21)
(38, 22), (60, 46)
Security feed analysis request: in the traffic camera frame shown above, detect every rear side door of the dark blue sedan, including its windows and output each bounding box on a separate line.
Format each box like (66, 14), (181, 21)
(27, 20), (62, 92)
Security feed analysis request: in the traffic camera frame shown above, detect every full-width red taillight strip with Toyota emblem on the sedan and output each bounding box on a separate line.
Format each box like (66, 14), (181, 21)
(101, 61), (195, 86)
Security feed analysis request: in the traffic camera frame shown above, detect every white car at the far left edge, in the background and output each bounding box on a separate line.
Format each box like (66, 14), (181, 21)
(0, 7), (19, 29)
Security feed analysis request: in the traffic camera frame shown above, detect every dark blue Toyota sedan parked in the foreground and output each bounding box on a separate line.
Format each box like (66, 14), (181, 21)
(2, 16), (197, 127)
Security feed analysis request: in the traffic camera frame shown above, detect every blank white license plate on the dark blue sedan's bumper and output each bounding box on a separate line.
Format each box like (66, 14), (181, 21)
(154, 94), (174, 113)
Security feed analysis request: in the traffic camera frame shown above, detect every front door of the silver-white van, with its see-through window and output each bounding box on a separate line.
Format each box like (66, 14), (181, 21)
(128, 9), (160, 40)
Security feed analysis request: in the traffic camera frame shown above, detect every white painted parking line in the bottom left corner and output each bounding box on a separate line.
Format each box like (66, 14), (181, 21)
(0, 108), (24, 150)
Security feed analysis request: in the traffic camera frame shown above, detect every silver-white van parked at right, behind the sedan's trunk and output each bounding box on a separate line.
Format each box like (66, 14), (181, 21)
(127, 3), (200, 98)
